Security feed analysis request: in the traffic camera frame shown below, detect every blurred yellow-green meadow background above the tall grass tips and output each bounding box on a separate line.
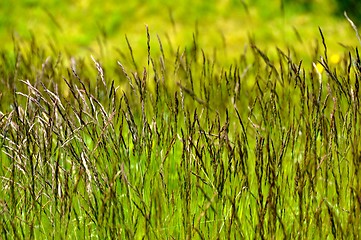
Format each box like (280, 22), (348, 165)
(0, 0), (361, 62)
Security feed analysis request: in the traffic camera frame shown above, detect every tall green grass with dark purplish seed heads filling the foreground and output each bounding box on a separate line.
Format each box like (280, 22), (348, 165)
(0, 23), (361, 239)
